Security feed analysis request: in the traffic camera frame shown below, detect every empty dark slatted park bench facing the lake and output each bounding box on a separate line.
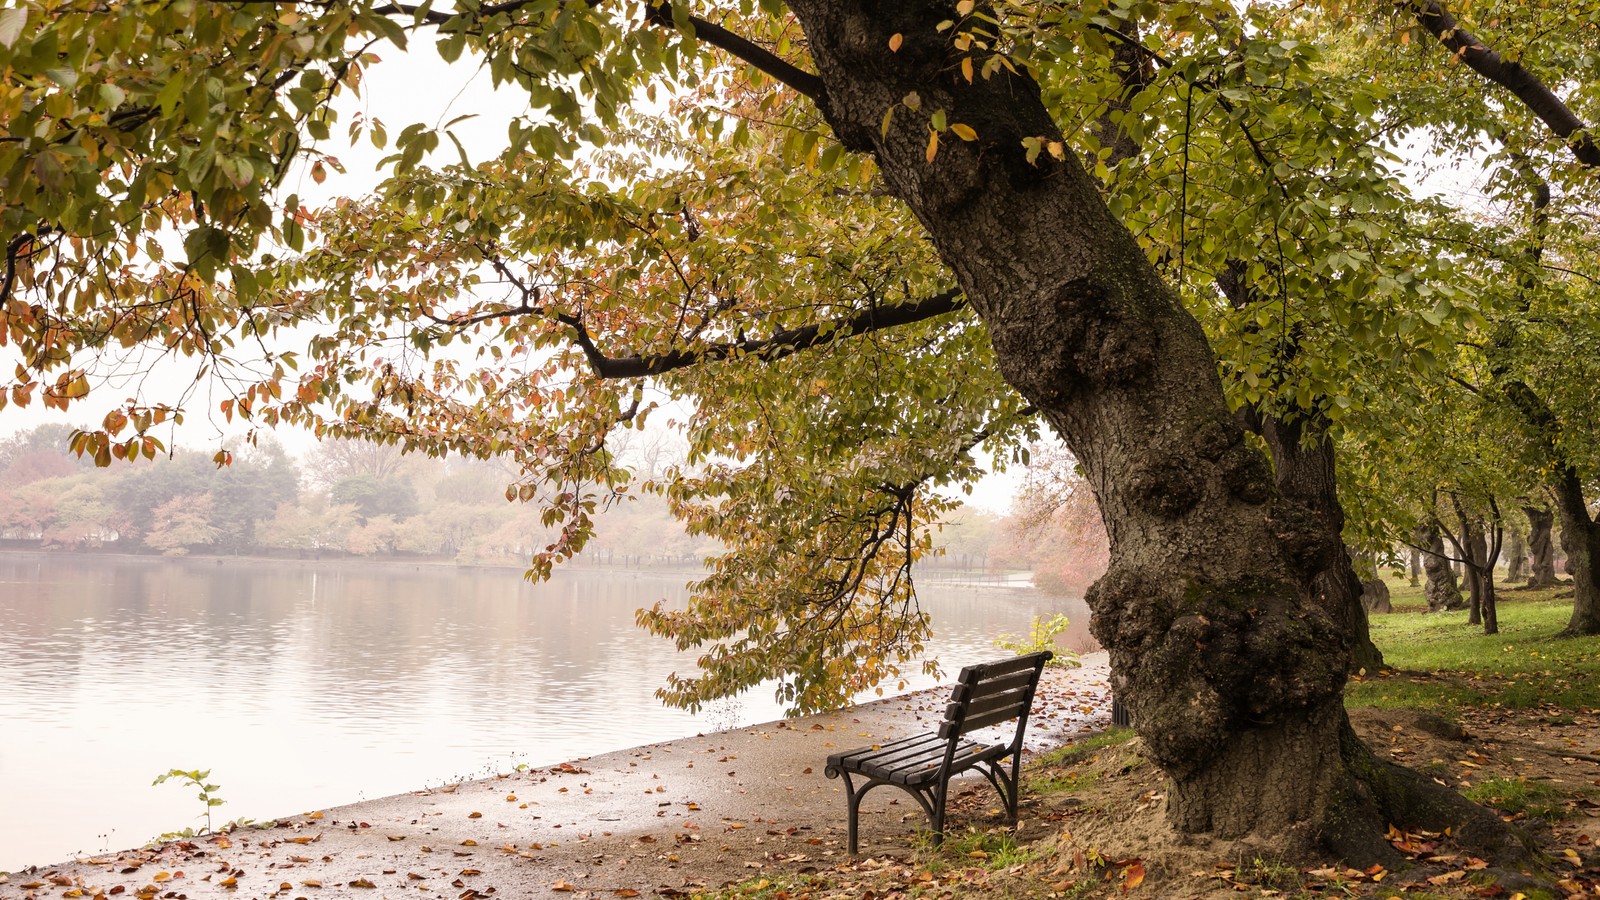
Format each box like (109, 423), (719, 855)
(824, 650), (1053, 854)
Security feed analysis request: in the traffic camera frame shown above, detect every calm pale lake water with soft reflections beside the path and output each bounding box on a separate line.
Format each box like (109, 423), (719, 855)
(0, 554), (1088, 871)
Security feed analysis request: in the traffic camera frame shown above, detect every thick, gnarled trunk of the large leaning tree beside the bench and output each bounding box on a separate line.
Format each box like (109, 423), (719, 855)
(790, 0), (1515, 862)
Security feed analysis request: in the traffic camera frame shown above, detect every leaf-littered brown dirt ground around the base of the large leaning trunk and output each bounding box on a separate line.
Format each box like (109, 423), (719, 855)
(864, 688), (1600, 900)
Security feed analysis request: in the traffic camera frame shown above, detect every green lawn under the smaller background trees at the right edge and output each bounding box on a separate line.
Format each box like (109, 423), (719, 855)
(1346, 581), (1600, 709)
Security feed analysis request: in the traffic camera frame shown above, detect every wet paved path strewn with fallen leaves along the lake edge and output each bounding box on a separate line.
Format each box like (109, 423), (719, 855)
(0, 653), (1109, 900)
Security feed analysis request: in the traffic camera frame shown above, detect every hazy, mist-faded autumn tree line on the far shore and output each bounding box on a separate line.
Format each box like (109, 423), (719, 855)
(0, 424), (1030, 572)
